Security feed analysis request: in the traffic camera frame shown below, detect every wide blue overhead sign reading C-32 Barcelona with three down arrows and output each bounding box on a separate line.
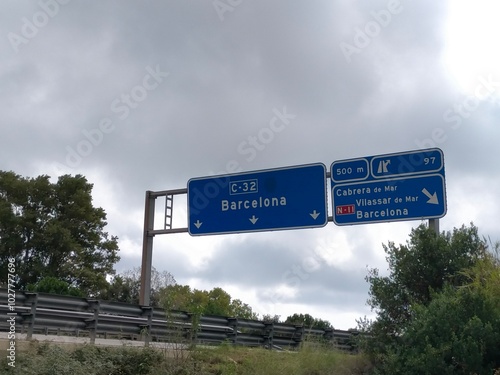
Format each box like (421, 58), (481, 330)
(187, 163), (328, 236)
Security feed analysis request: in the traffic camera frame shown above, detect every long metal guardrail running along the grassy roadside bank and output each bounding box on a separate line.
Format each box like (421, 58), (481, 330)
(0, 288), (359, 352)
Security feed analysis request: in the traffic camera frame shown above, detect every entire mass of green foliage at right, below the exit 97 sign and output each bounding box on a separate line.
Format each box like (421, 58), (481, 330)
(361, 227), (500, 375)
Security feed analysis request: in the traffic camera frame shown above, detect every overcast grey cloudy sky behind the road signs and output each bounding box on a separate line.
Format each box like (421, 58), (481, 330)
(0, 0), (500, 329)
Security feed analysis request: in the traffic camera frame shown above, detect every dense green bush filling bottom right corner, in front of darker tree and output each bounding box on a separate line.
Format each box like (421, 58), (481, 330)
(383, 248), (500, 375)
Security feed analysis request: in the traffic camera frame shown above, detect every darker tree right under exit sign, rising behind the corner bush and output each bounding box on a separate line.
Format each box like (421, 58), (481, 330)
(366, 224), (486, 336)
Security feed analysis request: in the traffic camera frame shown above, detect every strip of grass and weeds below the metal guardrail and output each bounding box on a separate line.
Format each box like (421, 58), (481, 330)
(0, 342), (369, 375)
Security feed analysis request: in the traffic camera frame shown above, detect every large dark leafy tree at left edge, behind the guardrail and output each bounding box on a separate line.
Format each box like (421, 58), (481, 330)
(0, 171), (119, 295)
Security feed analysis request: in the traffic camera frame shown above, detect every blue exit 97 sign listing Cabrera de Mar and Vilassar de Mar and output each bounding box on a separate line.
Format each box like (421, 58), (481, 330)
(331, 148), (446, 225)
